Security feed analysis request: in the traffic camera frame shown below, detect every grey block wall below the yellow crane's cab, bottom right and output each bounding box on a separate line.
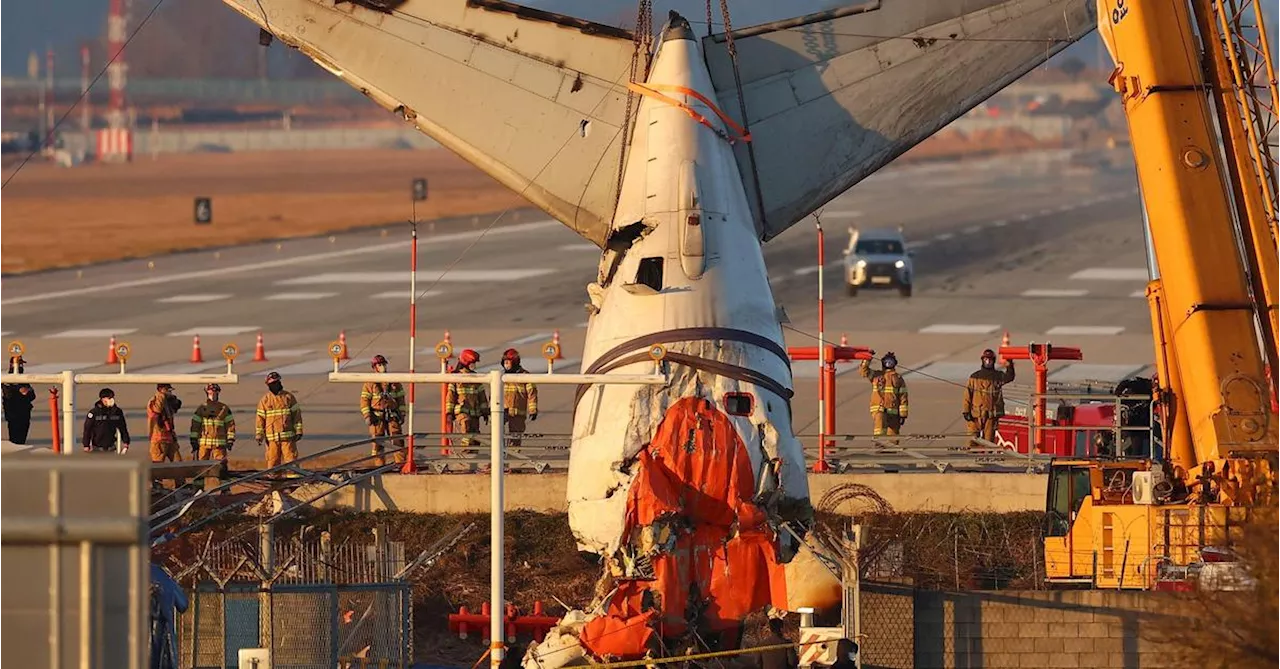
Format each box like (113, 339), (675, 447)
(861, 583), (1172, 669)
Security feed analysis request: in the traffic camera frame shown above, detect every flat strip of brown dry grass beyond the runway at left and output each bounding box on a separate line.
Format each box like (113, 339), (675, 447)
(0, 150), (527, 274)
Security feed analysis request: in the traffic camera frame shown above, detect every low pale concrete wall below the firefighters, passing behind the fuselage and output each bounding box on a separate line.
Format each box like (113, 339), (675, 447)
(298, 473), (1048, 513)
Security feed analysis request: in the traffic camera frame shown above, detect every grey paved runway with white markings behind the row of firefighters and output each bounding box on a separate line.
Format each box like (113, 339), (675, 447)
(0, 145), (1152, 455)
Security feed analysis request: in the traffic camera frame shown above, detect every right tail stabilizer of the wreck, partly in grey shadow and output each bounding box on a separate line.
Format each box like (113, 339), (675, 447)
(703, 0), (1097, 239)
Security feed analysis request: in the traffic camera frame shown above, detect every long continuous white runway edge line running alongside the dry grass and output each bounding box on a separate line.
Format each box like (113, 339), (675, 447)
(0, 220), (559, 304)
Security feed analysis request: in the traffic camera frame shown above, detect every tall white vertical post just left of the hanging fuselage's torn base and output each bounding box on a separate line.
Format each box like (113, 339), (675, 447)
(489, 367), (507, 669)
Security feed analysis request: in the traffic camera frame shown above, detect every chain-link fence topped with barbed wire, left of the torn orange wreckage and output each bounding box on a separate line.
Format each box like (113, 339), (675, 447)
(170, 532), (413, 669)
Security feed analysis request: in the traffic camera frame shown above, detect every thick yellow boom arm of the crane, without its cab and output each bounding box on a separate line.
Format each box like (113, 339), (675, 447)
(1098, 0), (1276, 468)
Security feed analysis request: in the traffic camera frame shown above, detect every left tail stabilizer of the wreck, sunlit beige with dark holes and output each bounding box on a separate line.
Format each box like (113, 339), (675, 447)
(224, 0), (635, 244)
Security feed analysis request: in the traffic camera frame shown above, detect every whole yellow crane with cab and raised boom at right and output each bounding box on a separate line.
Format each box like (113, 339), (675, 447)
(1044, 0), (1280, 588)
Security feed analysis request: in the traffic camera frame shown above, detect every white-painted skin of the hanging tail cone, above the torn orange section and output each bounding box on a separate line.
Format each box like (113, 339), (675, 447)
(567, 30), (809, 555)
